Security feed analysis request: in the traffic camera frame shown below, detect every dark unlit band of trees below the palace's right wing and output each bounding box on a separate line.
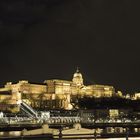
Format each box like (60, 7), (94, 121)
(77, 97), (140, 110)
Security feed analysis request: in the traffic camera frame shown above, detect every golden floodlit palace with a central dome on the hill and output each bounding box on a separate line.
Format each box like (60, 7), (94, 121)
(0, 69), (121, 109)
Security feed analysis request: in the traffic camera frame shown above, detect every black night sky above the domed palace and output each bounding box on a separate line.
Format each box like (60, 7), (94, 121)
(0, 0), (140, 93)
